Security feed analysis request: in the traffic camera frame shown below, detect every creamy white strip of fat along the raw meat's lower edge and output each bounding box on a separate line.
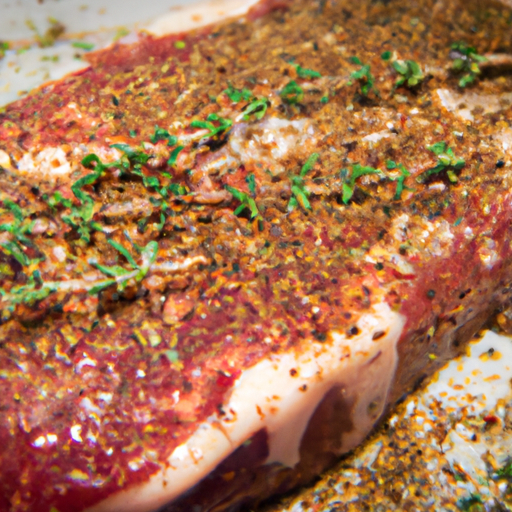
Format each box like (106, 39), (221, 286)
(88, 303), (405, 512)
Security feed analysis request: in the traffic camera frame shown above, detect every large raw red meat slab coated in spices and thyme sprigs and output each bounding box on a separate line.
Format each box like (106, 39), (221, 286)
(0, 0), (512, 512)
